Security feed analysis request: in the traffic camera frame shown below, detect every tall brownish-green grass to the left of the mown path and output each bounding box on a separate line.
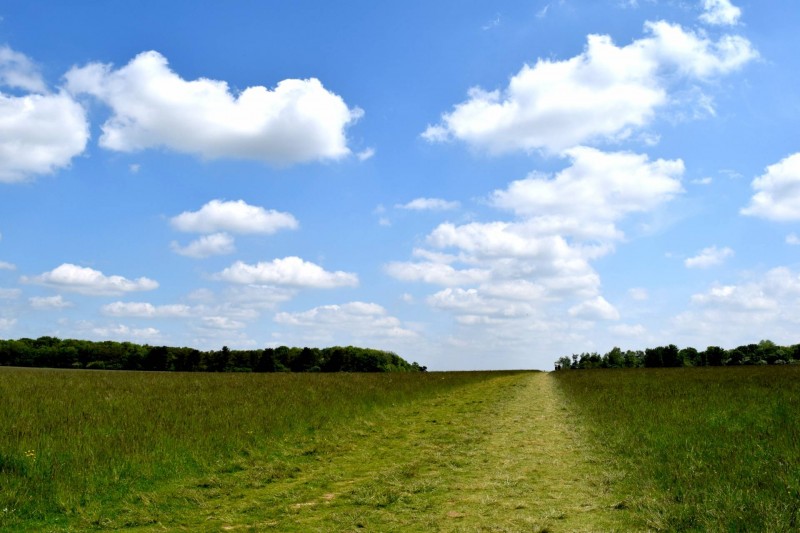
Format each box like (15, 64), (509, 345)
(0, 368), (496, 529)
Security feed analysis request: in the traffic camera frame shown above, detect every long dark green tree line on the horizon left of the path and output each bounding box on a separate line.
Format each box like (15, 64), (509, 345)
(0, 337), (427, 372)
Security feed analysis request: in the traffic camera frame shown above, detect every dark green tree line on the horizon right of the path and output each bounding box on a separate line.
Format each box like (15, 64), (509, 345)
(555, 340), (800, 370)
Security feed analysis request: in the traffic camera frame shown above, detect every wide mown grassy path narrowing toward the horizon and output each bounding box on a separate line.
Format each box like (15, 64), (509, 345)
(115, 373), (632, 531)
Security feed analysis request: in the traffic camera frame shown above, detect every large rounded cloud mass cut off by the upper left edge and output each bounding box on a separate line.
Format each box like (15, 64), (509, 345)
(0, 46), (89, 183)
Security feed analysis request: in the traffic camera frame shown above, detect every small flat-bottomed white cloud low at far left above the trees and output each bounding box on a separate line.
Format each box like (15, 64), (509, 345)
(21, 263), (158, 295)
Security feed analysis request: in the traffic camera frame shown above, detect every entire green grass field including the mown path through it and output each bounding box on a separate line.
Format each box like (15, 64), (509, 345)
(0, 366), (800, 531)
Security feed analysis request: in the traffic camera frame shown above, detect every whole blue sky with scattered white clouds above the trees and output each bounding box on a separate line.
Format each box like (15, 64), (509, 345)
(0, 0), (800, 370)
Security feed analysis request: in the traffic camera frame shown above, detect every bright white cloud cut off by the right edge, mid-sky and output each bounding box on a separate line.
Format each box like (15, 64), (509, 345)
(740, 153), (800, 222)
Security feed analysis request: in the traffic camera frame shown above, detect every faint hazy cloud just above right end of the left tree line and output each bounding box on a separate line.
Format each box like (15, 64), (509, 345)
(275, 302), (417, 344)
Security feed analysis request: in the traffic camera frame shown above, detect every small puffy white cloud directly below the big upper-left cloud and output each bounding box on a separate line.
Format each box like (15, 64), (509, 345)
(170, 200), (298, 234)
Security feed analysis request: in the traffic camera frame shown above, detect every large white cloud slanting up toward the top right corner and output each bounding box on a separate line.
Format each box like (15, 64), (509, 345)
(423, 21), (757, 154)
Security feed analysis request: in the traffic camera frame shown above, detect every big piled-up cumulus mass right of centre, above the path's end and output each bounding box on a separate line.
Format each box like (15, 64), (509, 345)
(386, 143), (684, 330)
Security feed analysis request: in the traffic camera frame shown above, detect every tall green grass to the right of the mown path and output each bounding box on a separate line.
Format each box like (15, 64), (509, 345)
(554, 366), (800, 531)
